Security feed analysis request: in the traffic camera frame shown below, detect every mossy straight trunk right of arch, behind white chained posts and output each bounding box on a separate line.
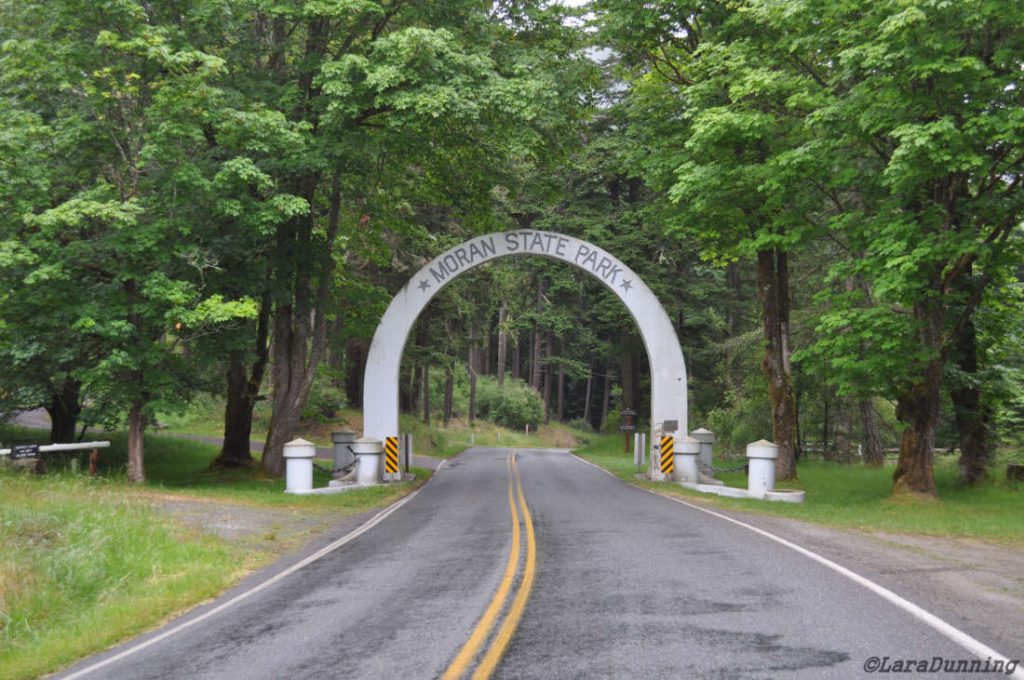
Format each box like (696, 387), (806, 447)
(758, 249), (800, 480)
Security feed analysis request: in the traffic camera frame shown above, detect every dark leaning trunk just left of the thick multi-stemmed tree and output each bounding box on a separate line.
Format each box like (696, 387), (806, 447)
(212, 295), (270, 468)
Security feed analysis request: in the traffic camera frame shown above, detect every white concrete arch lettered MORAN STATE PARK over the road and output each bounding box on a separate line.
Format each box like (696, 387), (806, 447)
(362, 229), (687, 462)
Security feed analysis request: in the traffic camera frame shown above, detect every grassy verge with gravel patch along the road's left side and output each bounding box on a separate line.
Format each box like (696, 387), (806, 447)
(0, 432), (429, 680)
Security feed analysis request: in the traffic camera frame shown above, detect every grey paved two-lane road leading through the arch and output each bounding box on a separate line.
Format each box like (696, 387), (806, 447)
(54, 449), (1020, 680)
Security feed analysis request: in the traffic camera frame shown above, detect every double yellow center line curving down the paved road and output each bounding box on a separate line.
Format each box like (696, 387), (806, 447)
(441, 454), (537, 680)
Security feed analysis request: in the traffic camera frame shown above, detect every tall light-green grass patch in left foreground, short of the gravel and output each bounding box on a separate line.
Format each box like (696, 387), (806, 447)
(0, 471), (237, 680)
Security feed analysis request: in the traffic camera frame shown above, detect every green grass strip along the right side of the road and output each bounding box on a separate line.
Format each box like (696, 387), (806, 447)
(575, 436), (1024, 545)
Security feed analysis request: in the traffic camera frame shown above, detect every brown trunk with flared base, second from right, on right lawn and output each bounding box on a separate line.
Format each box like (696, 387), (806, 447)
(893, 300), (945, 496)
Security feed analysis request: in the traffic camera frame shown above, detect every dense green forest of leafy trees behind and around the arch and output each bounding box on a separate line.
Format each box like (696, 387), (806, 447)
(0, 0), (1024, 495)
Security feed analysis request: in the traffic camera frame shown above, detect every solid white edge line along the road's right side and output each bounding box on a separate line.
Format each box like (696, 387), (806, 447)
(569, 452), (1024, 680)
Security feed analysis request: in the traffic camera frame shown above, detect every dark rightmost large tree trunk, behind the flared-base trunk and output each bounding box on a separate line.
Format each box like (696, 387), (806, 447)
(950, 321), (990, 484)
